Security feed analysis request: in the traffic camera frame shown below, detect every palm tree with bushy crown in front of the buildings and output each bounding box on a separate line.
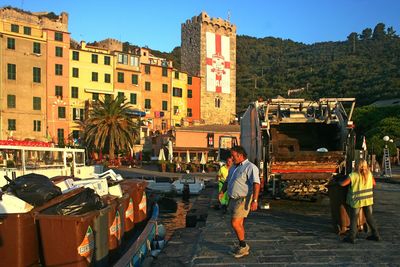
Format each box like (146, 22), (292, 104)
(81, 96), (138, 159)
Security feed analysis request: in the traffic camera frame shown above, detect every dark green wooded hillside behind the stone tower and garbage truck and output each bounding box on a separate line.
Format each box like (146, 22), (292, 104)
(153, 23), (400, 112)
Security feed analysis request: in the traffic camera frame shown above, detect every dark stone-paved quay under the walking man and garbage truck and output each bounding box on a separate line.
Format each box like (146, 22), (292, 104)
(152, 183), (400, 266)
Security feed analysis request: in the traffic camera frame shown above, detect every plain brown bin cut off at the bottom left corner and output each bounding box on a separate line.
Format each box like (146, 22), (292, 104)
(0, 212), (39, 267)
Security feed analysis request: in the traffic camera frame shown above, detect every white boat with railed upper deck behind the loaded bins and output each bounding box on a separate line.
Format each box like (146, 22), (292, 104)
(0, 145), (97, 186)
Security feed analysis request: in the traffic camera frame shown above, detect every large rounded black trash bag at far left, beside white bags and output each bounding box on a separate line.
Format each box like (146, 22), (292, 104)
(9, 173), (62, 207)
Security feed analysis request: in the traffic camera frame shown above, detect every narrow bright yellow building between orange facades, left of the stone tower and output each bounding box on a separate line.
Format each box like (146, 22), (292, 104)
(171, 70), (188, 126)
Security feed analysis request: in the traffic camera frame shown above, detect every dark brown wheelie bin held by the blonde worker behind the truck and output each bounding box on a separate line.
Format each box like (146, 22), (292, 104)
(328, 181), (366, 235)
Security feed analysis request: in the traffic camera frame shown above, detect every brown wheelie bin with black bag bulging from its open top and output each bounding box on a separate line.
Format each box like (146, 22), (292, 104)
(35, 188), (108, 267)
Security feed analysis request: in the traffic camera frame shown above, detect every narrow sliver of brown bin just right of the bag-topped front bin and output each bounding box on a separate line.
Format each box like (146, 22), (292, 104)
(102, 195), (124, 261)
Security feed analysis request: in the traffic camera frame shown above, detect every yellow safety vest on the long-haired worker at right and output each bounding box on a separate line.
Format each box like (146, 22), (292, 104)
(347, 172), (374, 208)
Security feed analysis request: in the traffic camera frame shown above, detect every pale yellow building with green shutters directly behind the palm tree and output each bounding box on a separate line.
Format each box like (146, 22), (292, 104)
(70, 42), (115, 139)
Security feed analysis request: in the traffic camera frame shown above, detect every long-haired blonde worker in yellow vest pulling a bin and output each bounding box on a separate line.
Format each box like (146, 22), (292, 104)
(340, 159), (381, 244)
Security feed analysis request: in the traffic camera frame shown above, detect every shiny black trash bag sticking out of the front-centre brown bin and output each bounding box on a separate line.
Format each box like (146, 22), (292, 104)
(41, 188), (106, 215)
